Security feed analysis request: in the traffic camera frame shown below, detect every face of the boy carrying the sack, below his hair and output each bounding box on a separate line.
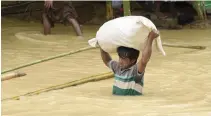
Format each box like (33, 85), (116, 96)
(119, 57), (135, 69)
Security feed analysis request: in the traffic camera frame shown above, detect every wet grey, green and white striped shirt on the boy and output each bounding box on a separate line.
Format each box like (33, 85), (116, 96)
(108, 60), (144, 95)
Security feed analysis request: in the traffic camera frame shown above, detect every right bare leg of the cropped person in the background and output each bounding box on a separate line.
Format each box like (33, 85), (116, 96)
(67, 18), (83, 39)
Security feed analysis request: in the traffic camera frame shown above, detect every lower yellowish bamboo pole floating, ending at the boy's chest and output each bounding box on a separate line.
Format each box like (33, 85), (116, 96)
(1, 72), (113, 101)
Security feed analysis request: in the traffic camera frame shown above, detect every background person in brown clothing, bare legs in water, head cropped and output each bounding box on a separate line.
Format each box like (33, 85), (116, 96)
(42, 0), (82, 38)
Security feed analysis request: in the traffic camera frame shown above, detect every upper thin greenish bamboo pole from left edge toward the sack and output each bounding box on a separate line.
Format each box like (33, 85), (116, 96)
(1, 47), (94, 74)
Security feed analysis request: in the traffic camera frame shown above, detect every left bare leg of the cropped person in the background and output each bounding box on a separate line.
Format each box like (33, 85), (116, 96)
(42, 13), (51, 35)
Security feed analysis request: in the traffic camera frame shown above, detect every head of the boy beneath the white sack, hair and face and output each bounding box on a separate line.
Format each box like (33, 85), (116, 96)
(117, 46), (139, 69)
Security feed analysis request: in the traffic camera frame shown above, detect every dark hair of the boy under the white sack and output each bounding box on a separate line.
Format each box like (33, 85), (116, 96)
(117, 46), (139, 60)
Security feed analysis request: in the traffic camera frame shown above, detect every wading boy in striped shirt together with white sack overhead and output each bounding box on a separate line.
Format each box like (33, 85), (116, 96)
(89, 16), (165, 95)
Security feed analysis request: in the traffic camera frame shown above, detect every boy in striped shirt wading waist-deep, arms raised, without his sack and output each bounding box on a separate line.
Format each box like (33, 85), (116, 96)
(100, 31), (159, 95)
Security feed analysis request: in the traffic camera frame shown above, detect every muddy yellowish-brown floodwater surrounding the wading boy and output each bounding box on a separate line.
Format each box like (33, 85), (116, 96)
(1, 18), (211, 116)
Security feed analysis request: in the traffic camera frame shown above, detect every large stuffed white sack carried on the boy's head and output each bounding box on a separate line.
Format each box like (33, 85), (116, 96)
(88, 16), (165, 55)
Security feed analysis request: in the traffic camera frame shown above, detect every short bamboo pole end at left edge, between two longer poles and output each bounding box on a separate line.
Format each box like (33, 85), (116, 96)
(1, 72), (26, 81)
